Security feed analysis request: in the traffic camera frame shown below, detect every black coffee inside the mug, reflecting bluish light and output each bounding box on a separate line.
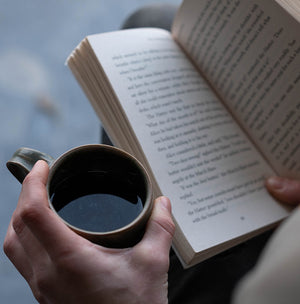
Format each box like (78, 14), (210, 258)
(51, 172), (143, 232)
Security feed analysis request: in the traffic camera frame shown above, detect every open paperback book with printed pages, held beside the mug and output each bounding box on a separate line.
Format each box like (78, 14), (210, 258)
(67, 0), (300, 267)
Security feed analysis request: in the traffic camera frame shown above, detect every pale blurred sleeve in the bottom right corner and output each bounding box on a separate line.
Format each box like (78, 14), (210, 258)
(233, 207), (300, 304)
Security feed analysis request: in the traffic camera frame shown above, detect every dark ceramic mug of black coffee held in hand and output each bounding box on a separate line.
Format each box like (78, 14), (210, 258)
(7, 144), (153, 248)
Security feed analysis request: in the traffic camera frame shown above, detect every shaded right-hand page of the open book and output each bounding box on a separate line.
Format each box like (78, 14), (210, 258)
(173, 0), (300, 178)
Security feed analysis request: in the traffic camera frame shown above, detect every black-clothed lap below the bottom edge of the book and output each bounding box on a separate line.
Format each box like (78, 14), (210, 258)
(169, 231), (272, 304)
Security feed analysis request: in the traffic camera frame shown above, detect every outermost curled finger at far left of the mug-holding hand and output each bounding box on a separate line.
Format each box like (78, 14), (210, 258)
(3, 222), (32, 281)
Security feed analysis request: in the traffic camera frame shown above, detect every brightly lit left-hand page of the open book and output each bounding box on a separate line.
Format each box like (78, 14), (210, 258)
(88, 29), (287, 258)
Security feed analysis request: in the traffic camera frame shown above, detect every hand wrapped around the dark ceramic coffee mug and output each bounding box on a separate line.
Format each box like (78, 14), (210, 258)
(4, 161), (174, 304)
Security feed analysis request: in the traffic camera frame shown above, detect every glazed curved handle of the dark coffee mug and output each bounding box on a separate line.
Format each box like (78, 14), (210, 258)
(6, 148), (55, 184)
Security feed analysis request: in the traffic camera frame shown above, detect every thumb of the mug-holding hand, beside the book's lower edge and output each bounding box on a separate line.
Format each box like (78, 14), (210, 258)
(135, 197), (175, 264)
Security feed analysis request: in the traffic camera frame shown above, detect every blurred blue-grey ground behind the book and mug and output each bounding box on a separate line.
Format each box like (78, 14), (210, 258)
(0, 0), (181, 304)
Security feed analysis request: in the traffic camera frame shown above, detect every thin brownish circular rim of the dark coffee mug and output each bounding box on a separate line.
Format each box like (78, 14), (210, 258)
(46, 144), (153, 237)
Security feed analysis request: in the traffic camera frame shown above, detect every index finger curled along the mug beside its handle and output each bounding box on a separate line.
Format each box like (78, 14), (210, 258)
(17, 161), (83, 259)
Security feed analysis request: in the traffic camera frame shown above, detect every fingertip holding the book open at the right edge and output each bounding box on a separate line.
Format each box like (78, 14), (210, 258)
(266, 176), (300, 205)
